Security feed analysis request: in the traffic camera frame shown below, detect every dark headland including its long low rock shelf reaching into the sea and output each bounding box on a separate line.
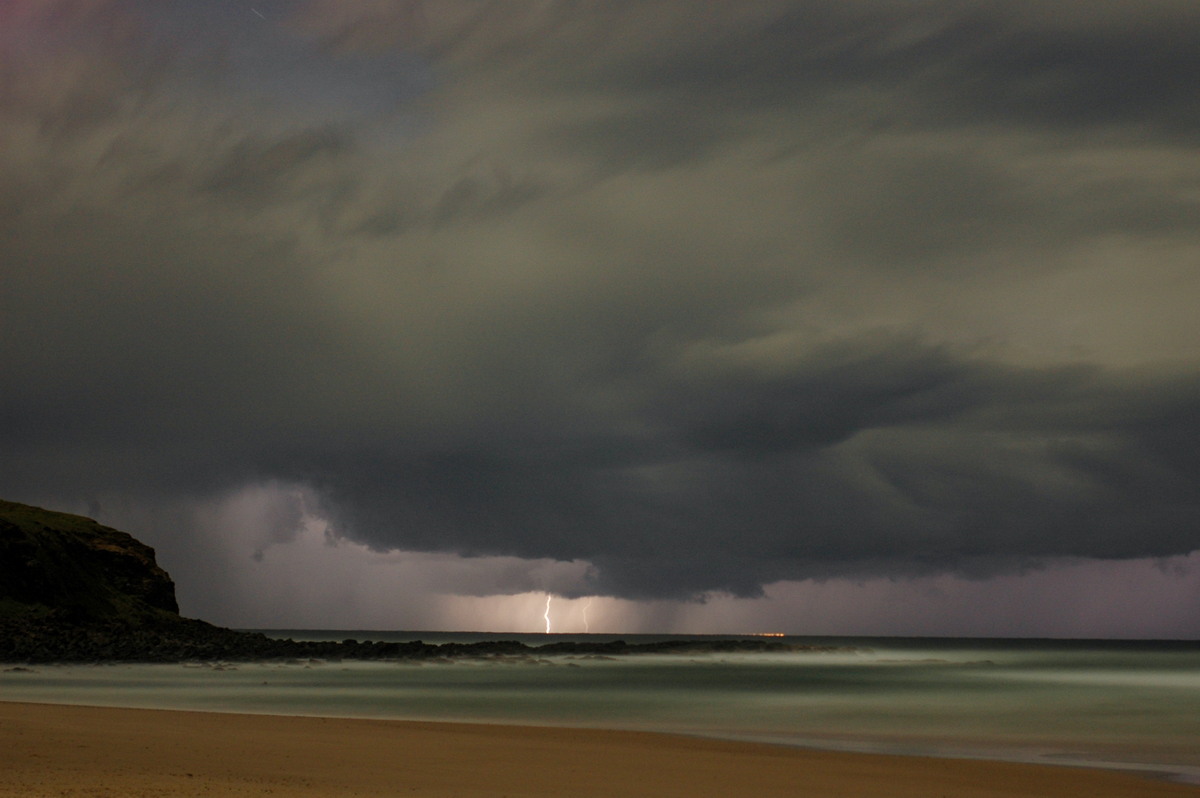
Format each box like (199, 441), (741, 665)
(0, 500), (820, 664)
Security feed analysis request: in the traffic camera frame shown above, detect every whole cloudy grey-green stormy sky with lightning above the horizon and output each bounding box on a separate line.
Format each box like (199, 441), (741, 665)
(0, 0), (1200, 637)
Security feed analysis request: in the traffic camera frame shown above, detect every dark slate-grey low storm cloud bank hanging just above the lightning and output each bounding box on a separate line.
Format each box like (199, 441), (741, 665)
(307, 333), (1200, 596)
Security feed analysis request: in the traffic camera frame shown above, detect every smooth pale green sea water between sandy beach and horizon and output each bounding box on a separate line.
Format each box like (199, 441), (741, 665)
(0, 630), (1200, 780)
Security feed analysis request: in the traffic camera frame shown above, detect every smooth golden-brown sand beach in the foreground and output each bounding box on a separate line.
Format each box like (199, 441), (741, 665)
(0, 702), (1200, 798)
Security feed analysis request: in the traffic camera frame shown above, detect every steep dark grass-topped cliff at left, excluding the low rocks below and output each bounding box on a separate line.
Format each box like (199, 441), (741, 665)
(0, 500), (179, 624)
